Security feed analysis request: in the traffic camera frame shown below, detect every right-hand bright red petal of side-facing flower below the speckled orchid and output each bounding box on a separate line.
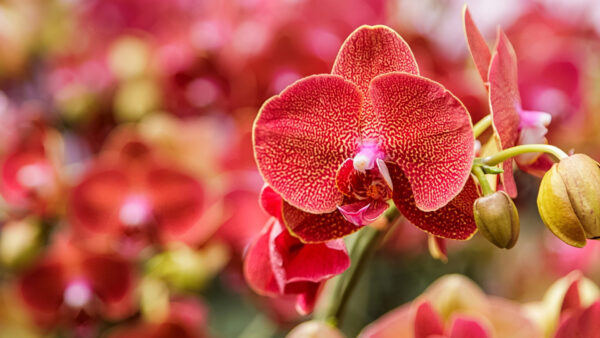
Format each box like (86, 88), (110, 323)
(270, 222), (350, 289)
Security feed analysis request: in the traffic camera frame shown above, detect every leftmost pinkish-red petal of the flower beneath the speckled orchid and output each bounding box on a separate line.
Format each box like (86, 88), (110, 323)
(244, 217), (280, 296)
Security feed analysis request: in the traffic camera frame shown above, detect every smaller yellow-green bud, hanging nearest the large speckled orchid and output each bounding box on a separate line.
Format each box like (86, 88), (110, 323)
(473, 191), (519, 249)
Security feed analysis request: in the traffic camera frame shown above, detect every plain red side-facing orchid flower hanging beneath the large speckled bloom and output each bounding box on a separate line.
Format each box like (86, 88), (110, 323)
(244, 186), (350, 313)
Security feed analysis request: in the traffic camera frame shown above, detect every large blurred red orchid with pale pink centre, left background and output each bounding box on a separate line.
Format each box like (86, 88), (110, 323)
(69, 133), (216, 253)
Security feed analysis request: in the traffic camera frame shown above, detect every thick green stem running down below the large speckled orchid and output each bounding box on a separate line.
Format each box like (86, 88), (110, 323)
(315, 207), (401, 326)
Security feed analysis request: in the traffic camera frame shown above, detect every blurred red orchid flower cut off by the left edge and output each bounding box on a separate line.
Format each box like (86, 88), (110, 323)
(0, 122), (62, 215)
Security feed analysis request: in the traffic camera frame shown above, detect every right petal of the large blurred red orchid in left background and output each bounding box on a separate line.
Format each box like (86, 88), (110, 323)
(146, 168), (204, 235)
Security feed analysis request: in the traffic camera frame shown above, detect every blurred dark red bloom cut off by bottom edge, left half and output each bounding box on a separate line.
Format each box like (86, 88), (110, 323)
(108, 298), (208, 338)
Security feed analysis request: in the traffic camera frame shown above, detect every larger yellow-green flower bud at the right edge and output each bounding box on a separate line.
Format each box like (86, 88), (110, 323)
(537, 154), (600, 247)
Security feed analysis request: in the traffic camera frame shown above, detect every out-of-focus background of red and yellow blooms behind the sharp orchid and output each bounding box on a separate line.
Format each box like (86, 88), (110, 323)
(0, 0), (600, 337)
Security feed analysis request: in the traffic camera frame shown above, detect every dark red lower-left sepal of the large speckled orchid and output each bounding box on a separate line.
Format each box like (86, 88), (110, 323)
(282, 202), (361, 243)
